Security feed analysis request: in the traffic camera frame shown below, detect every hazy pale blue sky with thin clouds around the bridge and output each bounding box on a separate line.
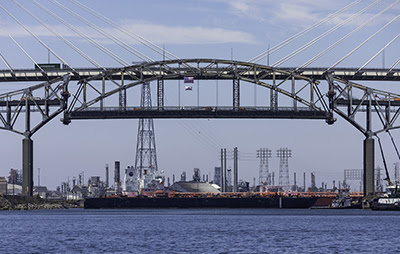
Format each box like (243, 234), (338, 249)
(0, 0), (400, 189)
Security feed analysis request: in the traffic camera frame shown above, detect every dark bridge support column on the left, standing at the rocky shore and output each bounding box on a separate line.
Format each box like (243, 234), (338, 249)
(22, 137), (33, 196)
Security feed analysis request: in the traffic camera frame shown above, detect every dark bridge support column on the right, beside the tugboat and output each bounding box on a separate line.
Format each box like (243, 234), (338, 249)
(363, 136), (375, 197)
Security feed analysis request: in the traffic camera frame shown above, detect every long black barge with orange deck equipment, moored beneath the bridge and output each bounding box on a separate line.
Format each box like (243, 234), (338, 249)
(84, 191), (344, 209)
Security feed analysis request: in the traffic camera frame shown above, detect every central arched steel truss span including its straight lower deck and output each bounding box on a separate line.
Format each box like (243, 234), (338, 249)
(60, 59), (333, 124)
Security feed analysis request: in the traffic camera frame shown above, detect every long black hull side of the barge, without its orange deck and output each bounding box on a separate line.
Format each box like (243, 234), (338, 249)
(84, 197), (318, 209)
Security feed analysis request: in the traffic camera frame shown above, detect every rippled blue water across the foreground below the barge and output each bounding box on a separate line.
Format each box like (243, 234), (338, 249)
(0, 209), (400, 253)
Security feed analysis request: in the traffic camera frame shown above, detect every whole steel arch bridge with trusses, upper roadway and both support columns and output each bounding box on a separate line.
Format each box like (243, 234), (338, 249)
(0, 59), (400, 195)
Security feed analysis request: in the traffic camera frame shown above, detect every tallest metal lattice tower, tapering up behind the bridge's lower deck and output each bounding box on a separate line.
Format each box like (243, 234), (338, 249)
(135, 82), (158, 177)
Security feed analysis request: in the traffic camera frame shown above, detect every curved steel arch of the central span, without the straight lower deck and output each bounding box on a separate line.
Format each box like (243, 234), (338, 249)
(64, 59), (333, 123)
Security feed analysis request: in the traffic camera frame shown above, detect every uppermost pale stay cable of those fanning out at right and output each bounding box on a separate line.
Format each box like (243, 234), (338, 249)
(248, 0), (363, 63)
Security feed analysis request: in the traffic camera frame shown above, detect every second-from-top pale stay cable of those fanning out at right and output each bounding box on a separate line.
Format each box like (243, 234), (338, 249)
(272, 0), (382, 67)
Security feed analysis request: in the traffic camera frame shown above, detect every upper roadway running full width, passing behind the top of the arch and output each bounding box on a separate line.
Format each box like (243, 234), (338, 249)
(0, 64), (400, 82)
